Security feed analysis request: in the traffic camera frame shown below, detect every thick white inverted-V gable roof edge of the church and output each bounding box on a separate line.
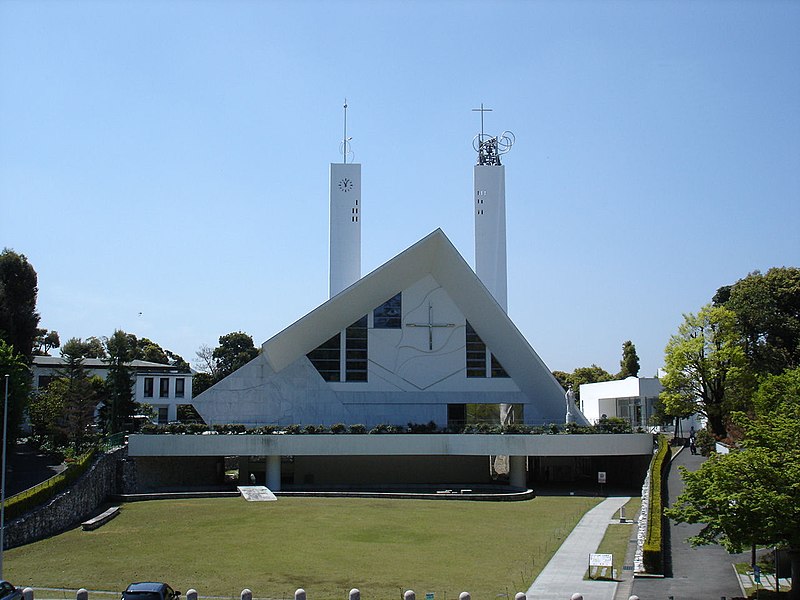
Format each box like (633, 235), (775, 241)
(262, 229), (566, 415)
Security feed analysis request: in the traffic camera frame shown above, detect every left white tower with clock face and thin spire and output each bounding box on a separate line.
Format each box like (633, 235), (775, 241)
(329, 100), (361, 298)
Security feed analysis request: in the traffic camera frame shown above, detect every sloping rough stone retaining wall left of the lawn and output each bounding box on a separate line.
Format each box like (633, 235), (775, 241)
(4, 448), (127, 549)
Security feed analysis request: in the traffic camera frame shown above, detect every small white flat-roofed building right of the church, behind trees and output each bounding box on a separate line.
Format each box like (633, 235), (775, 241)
(579, 377), (664, 429)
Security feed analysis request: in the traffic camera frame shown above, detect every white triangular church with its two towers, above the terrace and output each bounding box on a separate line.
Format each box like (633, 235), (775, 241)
(193, 120), (586, 427)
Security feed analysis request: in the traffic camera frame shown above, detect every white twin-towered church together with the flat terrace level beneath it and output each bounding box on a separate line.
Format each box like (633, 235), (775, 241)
(129, 107), (652, 490)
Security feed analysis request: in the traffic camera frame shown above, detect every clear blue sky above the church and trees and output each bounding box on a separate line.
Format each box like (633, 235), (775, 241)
(0, 0), (800, 375)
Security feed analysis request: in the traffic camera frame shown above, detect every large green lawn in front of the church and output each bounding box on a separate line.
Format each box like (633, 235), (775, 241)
(4, 496), (599, 600)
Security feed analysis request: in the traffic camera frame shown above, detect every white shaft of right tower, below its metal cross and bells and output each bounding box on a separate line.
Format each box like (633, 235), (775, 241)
(473, 165), (508, 312)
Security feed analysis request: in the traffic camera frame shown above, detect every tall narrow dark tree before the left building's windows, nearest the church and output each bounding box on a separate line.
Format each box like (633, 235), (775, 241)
(100, 330), (136, 433)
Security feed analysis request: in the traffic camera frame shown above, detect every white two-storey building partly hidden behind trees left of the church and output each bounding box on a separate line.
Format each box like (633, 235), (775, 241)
(33, 356), (193, 424)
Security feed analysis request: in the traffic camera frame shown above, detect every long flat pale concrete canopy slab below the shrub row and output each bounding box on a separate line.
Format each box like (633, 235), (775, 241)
(128, 433), (653, 457)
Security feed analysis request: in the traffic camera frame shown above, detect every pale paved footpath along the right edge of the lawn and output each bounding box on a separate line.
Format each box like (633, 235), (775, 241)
(526, 497), (630, 600)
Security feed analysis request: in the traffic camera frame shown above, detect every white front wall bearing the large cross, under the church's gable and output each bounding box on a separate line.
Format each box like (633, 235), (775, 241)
(193, 275), (540, 427)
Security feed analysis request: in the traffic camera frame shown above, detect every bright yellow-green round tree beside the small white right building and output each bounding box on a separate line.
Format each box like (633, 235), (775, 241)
(660, 305), (752, 437)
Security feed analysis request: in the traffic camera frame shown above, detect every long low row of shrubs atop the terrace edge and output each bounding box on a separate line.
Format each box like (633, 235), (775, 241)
(141, 419), (632, 435)
